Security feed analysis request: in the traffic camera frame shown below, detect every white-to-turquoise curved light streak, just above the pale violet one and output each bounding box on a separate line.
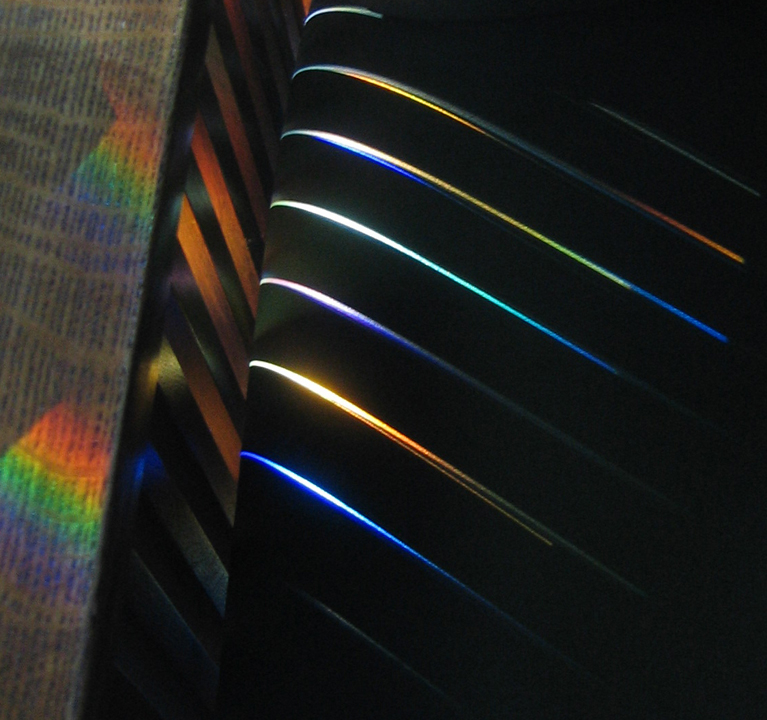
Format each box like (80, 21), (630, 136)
(271, 200), (619, 375)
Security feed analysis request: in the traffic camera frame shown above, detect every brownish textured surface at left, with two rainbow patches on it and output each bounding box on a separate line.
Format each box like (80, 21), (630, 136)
(0, 0), (187, 719)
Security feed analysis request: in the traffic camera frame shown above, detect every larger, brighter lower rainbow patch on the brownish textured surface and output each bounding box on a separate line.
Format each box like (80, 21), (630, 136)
(0, 403), (110, 606)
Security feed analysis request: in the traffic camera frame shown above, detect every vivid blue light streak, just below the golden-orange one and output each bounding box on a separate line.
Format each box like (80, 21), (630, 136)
(240, 451), (590, 675)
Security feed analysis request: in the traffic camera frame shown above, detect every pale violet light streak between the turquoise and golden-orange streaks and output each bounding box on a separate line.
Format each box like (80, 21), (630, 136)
(261, 277), (676, 507)
